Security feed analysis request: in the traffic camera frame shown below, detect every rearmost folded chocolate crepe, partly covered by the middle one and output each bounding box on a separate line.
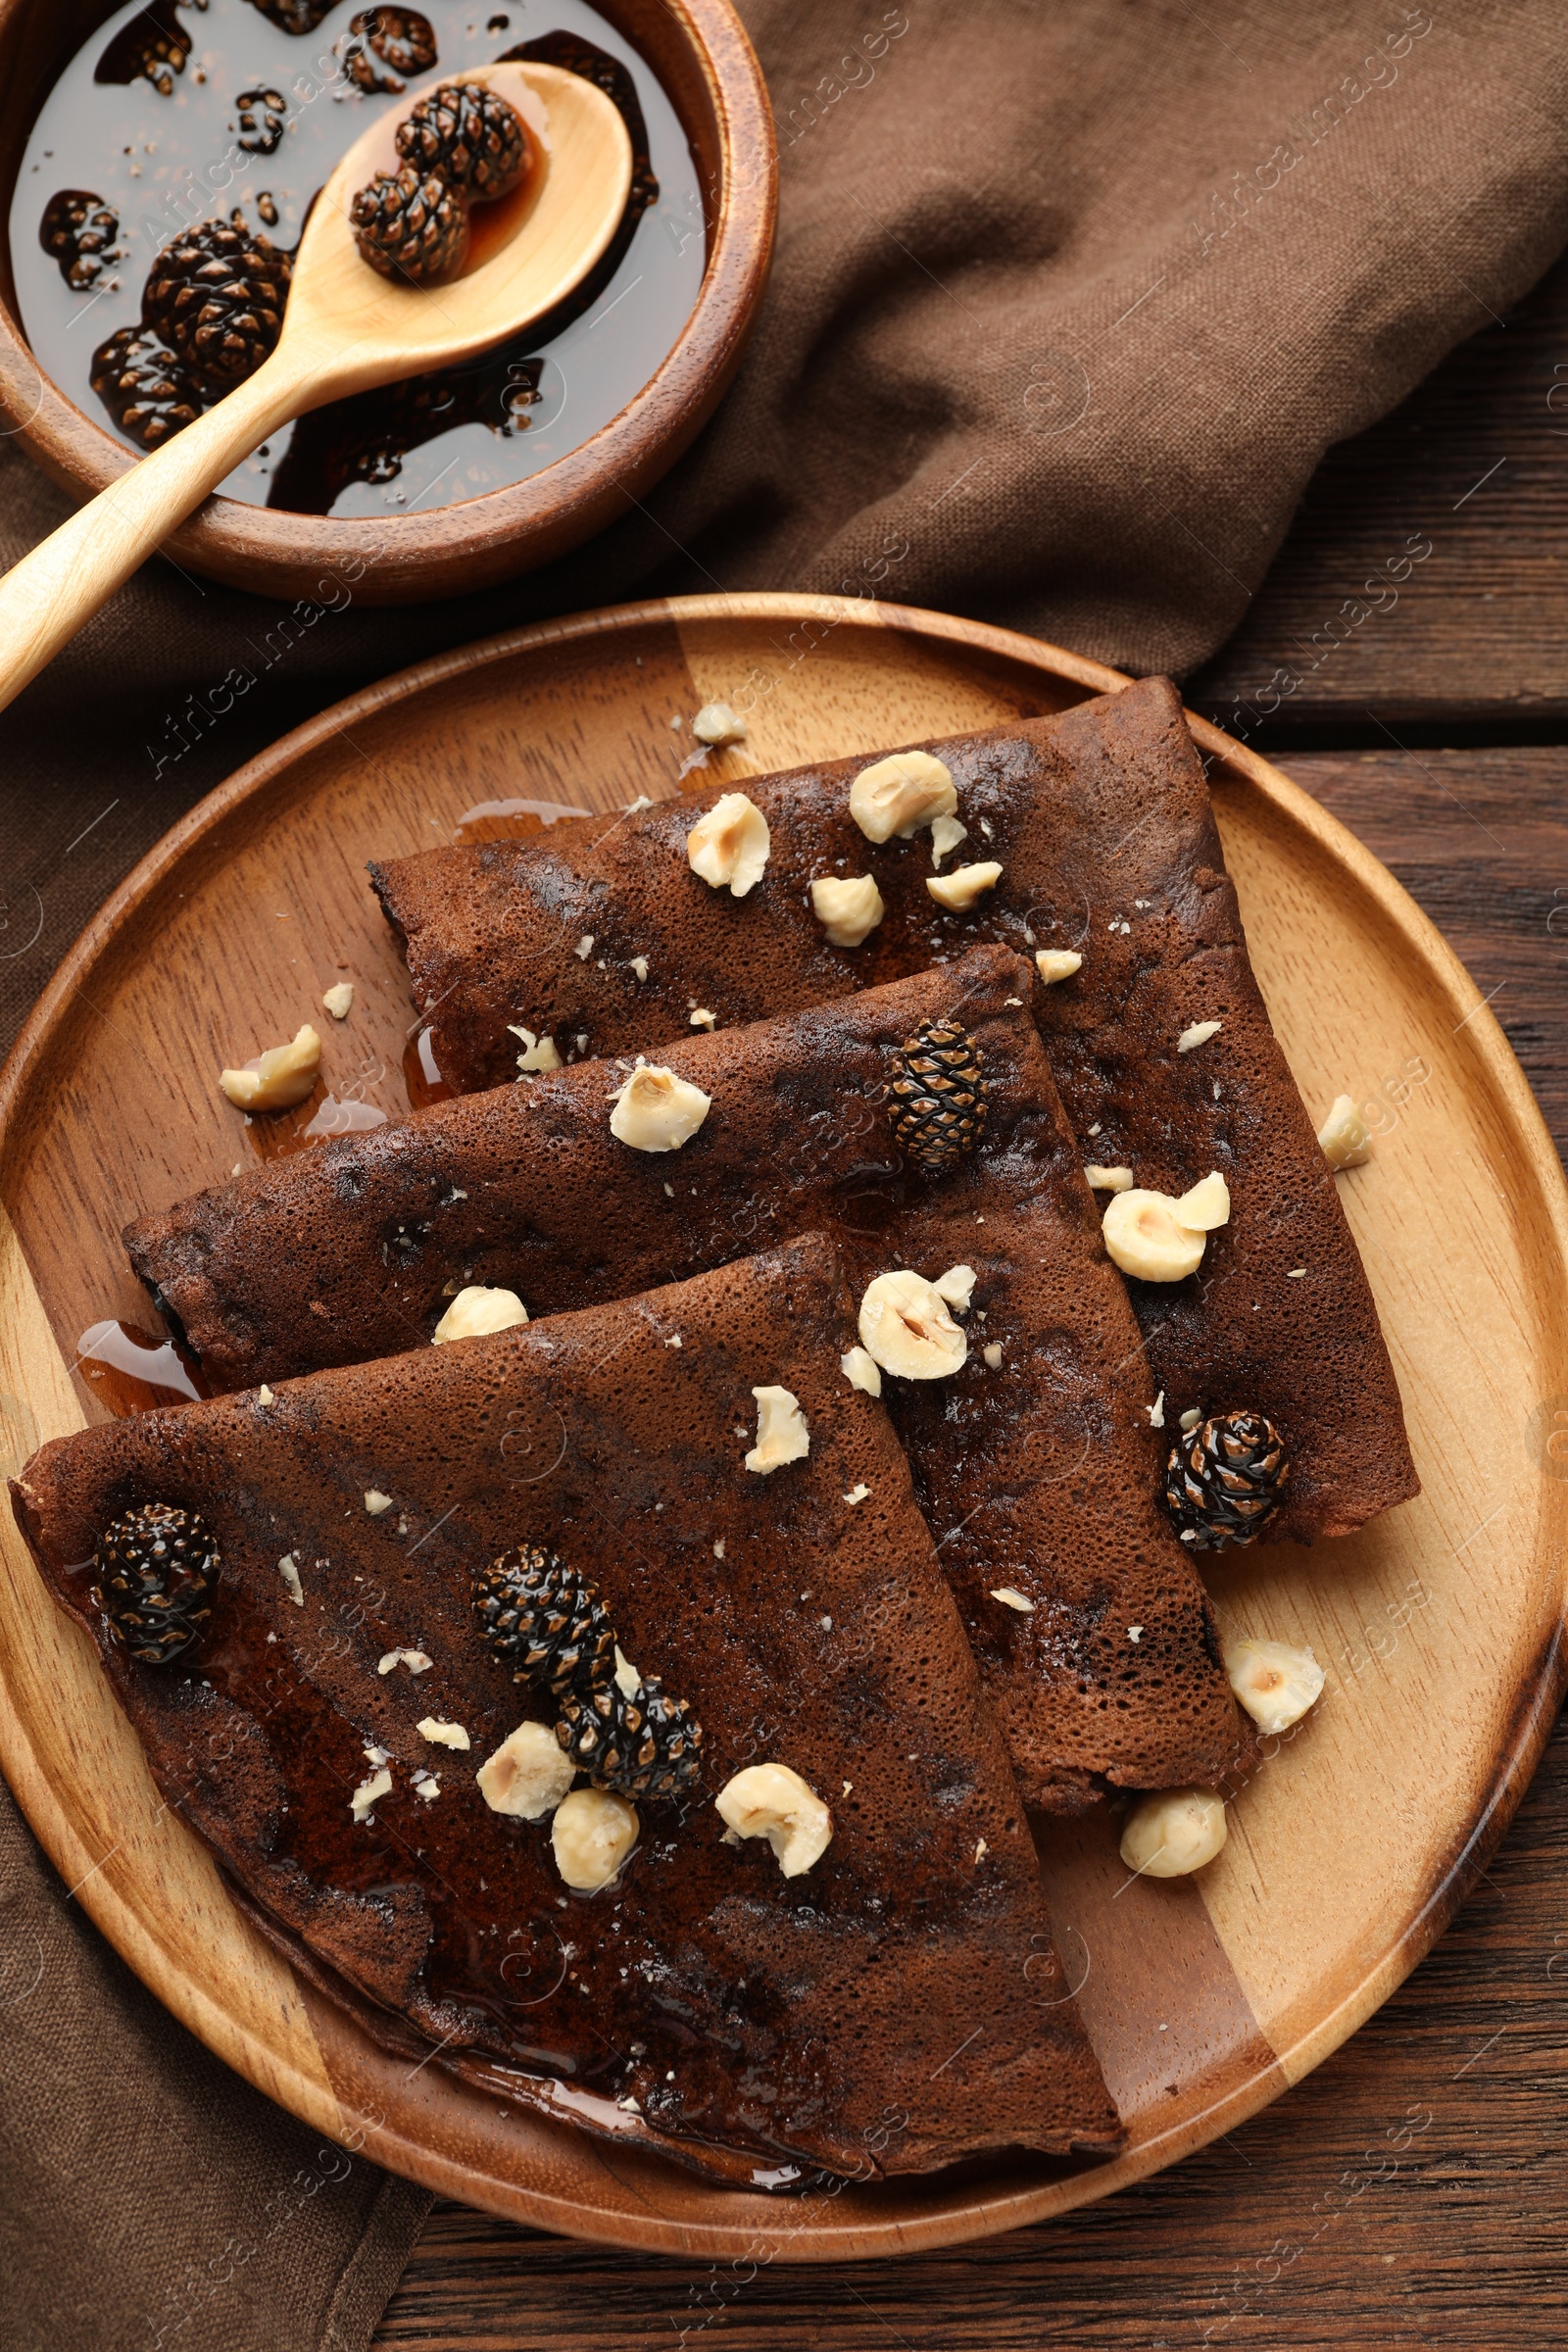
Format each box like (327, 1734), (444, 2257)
(371, 677), (1417, 1541)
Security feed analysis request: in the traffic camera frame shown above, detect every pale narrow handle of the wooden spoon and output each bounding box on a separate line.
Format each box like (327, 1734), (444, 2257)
(0, 351), (308, 710)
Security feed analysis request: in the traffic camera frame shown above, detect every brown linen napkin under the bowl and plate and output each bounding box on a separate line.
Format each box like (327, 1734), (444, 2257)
(0, 0), (1568, 2352)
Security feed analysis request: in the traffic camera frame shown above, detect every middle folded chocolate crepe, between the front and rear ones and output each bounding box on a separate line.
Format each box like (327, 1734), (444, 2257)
(127, 948), (1239, 1809)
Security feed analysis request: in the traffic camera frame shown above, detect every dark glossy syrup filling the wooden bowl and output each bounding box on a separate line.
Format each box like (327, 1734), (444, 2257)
(10, 0), (706, 519)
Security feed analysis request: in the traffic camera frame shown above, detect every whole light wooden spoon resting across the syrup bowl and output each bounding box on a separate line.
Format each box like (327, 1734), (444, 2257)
(0, 66), (632, 710)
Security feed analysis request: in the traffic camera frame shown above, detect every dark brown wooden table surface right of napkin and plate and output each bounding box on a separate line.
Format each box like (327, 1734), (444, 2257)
(14, 264), (1568, 2352)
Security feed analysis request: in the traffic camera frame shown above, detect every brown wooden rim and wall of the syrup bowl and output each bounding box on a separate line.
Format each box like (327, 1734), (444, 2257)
(0, 0), (778, 605)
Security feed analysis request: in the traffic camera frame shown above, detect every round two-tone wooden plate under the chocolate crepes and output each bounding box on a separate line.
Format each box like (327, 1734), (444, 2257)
(0, 595), (1568, 2263)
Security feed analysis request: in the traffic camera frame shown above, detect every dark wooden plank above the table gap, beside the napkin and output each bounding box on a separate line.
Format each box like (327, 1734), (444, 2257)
(1187, 261), (1568, 751)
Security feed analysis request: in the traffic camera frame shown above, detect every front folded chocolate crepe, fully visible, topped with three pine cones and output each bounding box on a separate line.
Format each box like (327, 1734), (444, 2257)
(14, 1237), (1119, 2180)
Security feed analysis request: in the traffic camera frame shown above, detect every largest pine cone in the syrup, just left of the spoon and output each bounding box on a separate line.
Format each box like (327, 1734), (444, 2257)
(141, 221), (291, 398)
